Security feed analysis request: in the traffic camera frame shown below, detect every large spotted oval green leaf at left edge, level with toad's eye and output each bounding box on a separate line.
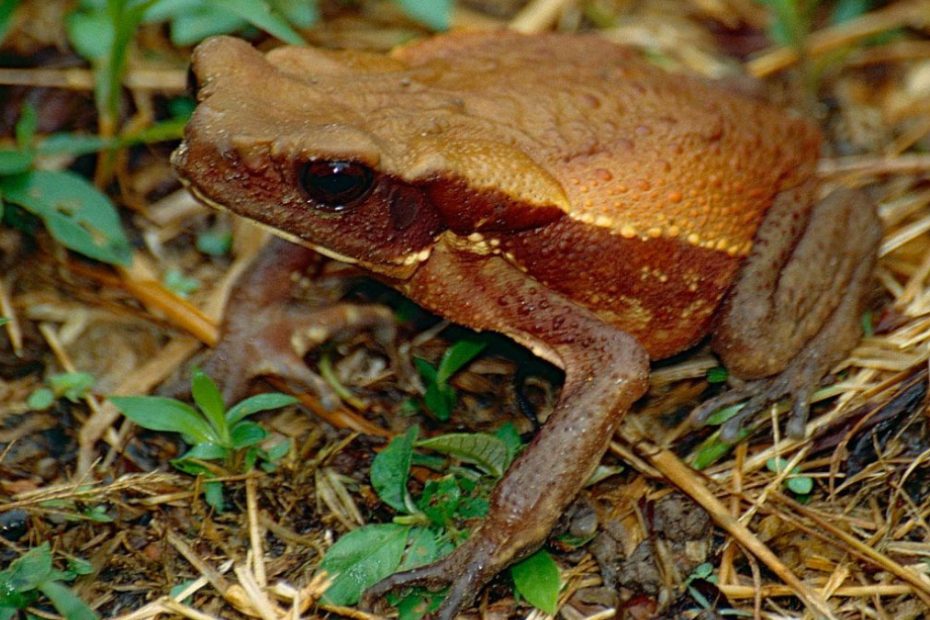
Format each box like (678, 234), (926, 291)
(0, 170), (132, 265)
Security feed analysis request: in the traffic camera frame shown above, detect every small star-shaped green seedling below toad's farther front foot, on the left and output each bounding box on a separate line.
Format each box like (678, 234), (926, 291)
(109, 370), (297, 510)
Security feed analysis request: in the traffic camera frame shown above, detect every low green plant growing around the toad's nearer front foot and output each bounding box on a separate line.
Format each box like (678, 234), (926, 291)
(321, 425), (559, 618)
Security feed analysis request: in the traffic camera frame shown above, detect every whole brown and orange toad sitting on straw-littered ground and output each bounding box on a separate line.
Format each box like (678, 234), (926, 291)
(173, 32), (880, 618)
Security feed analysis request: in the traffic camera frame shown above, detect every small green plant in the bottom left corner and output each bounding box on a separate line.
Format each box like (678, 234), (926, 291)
(0, 542), (98, 620)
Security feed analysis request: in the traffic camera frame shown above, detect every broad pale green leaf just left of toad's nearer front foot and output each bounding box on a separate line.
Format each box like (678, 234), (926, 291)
(320, 523), (410, 605)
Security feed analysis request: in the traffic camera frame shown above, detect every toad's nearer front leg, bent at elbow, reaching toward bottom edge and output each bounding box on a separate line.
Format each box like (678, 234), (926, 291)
(366, 243), (649, 618)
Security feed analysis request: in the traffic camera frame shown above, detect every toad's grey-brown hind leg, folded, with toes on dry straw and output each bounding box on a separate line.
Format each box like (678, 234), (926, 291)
(692, 188), (881, 440)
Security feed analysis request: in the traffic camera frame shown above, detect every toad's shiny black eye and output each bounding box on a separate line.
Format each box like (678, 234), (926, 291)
(300, 160), (374, 212)
